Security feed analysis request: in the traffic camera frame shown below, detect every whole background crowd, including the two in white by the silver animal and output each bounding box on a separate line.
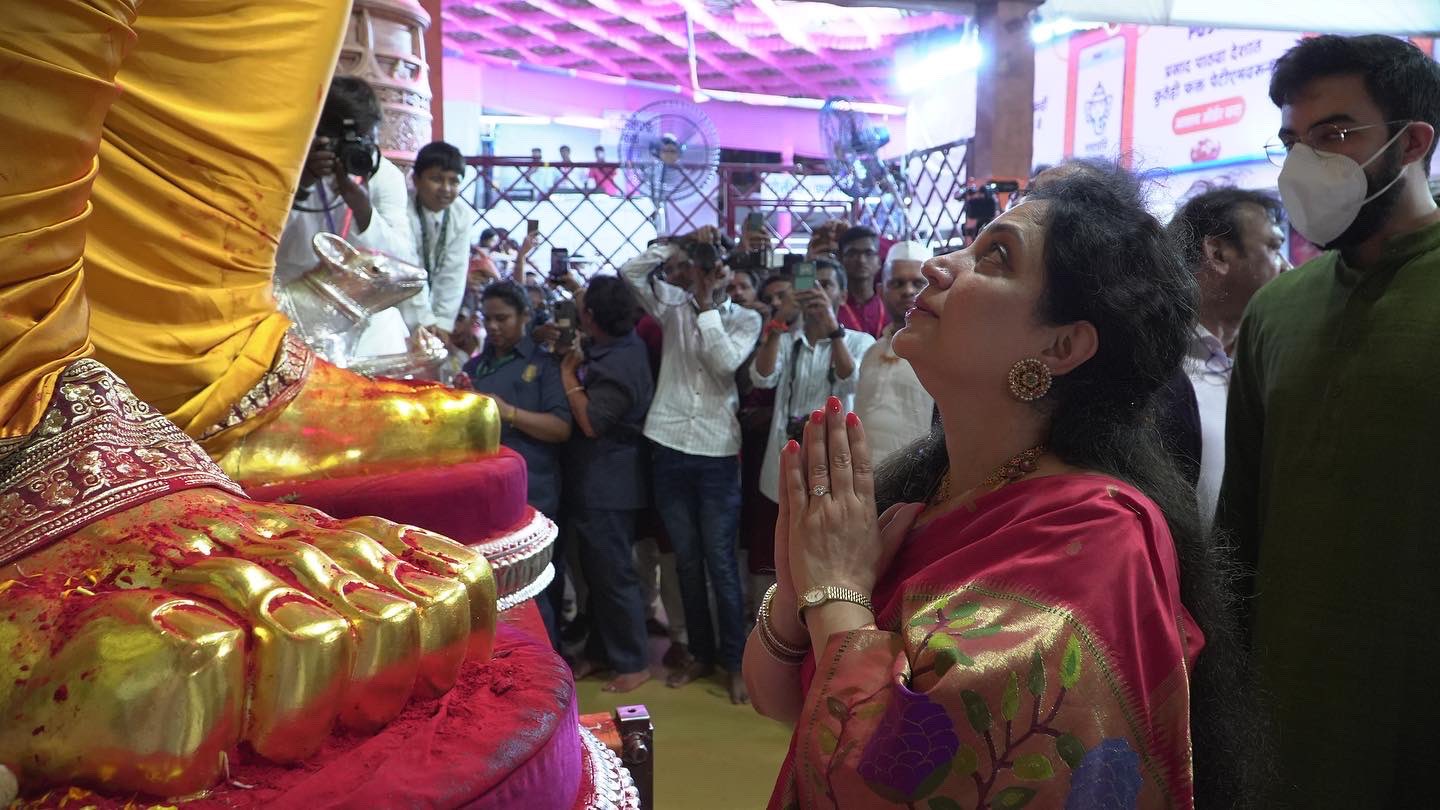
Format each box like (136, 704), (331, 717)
(276, 76), (933, 702)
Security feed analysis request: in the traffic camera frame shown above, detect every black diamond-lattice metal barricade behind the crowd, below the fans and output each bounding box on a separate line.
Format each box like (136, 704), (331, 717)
(461, 140), (969, 268)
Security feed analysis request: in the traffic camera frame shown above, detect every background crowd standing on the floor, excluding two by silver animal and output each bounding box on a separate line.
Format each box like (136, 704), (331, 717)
(459, 220), (933, 702)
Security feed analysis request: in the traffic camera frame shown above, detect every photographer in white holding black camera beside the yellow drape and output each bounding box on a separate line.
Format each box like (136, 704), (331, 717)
(275, 76), (419, 356)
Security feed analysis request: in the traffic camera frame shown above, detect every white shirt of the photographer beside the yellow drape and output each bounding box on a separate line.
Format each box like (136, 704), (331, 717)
(275, 156), (419, 357)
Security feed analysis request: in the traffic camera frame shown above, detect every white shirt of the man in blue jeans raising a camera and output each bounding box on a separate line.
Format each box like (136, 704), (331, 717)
(621, 245), (760, 458)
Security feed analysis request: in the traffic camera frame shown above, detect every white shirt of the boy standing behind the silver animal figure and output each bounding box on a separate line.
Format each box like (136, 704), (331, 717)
(399, 193), (480, 331)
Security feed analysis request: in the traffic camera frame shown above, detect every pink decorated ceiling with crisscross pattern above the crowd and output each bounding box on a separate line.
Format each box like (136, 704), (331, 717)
(442, 0), (965, 102)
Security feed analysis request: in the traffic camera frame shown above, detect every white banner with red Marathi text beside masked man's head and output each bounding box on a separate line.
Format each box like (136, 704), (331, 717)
(1032, 27), (1440, 216)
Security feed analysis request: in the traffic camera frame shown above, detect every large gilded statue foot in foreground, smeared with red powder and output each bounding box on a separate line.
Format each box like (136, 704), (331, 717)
(0, 360), (495, 797)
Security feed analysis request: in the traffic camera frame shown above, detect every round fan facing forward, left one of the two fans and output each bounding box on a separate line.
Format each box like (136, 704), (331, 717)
(621, 99), (720, 232)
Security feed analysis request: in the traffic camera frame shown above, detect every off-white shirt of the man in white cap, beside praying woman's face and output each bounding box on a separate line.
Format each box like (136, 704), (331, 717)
(855, 334), (935, 466)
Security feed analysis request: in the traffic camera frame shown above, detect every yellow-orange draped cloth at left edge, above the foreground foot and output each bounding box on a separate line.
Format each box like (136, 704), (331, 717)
(0, 1), (122, 441)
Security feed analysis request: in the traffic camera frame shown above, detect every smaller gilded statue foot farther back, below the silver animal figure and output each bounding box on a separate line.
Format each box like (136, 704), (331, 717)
(200, 337), (500, 486)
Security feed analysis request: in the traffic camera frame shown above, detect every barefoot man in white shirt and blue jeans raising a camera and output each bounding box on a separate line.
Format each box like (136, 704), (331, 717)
(621, 226), (760, 703)
